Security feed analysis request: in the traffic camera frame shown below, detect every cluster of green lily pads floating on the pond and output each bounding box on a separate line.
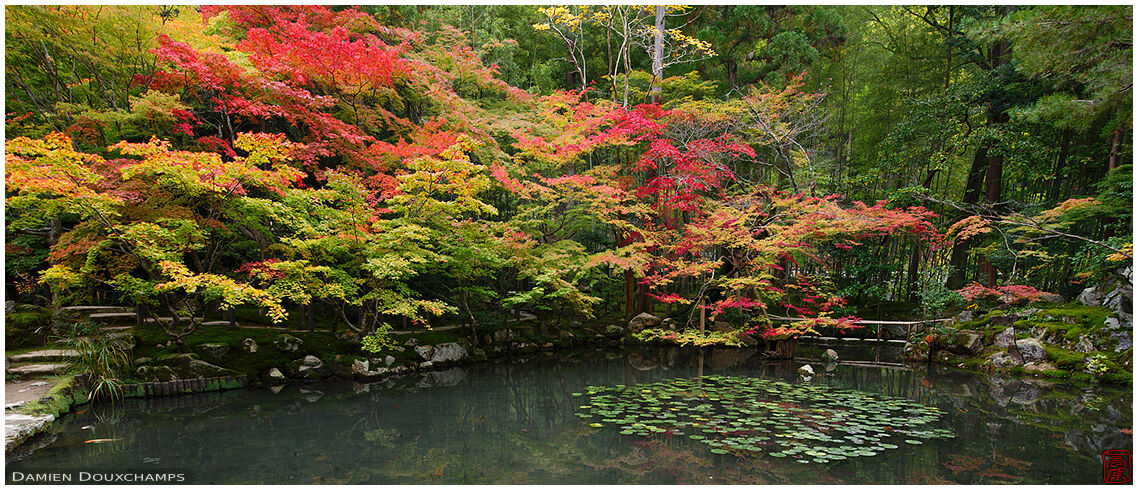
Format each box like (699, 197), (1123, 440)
(572, 375), (954, 463)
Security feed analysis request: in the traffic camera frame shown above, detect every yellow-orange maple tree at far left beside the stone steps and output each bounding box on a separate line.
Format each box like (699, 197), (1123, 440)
(6, 133), (300, 348)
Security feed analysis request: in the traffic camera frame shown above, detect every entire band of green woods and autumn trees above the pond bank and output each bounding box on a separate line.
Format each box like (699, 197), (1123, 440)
(5, 6), (1132, 347)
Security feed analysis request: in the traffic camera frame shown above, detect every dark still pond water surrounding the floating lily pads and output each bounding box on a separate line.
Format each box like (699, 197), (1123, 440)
(6, 349), (1133, 484)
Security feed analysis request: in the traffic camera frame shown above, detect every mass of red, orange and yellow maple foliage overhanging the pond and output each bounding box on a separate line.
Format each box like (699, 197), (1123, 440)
(6, 6), (1005, 350)
